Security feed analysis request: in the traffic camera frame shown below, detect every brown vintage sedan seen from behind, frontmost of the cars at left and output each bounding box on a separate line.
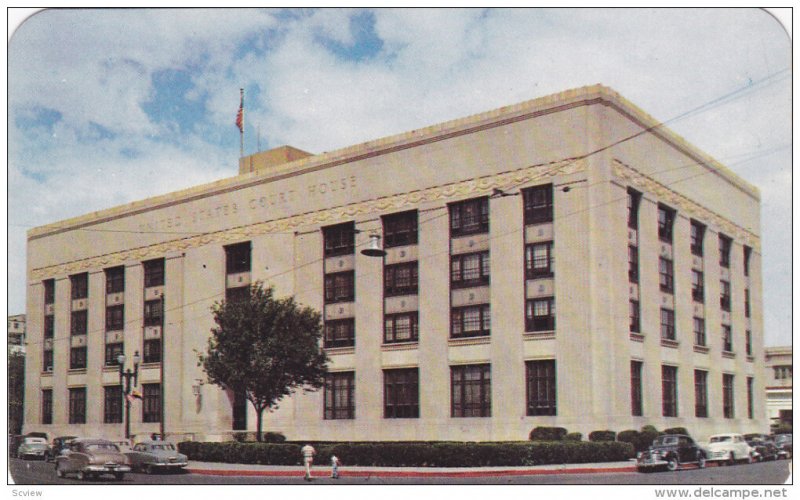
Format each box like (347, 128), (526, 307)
(56, 438), (131, 480)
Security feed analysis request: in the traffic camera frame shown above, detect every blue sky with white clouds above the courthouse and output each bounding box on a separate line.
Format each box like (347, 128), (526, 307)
(8, 9), (792, 345)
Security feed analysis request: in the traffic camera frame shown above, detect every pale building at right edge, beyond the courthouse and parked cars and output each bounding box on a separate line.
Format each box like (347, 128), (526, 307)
(764, 346), (792, 425)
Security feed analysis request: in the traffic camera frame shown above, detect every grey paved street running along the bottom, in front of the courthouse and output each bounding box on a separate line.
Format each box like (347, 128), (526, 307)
(9, 459), (790, 485)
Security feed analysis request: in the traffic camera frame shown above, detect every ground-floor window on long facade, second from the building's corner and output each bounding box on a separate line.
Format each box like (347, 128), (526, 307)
(450, 364), (492, 417)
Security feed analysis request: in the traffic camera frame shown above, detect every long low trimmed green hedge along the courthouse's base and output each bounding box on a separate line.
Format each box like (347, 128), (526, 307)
(178, 441), (635, 467)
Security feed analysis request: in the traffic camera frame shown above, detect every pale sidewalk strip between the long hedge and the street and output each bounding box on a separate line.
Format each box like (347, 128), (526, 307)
(186, 461), (636, 478)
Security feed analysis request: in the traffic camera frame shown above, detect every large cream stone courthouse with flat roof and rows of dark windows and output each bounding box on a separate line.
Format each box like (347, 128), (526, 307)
(25, 86), (768, 441)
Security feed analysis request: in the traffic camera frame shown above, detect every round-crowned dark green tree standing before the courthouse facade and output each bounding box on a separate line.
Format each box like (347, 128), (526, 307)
(198, 282), (328, 441)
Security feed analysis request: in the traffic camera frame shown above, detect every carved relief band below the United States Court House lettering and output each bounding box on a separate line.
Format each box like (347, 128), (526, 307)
(30, 159), (587, 280)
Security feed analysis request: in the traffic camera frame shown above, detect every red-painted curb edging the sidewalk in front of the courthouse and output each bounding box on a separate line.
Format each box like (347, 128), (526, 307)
(185, 466), (636, 478)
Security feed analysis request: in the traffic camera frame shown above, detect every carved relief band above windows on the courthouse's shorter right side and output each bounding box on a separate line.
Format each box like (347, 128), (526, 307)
(612, 159), (761, 252)
